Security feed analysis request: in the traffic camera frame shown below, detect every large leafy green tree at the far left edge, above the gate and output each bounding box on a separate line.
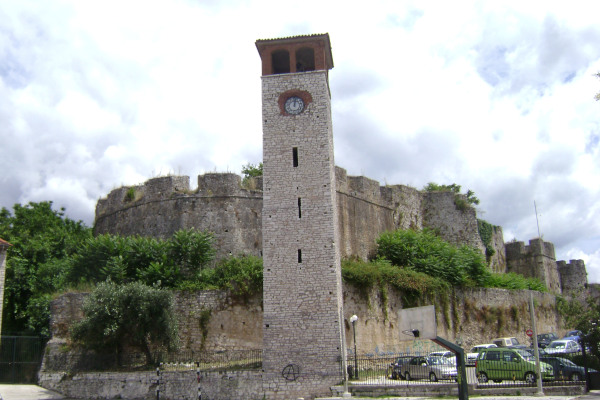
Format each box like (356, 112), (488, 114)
(0, 201), (92, 336)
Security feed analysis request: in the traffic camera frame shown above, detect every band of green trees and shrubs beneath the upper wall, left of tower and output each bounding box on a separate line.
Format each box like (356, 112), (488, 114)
(0, 202), (262, 337)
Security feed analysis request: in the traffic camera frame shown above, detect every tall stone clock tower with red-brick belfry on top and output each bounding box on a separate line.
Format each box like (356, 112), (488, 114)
(256, 34), (345, 399)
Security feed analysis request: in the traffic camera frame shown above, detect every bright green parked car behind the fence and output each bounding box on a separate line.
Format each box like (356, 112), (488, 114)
(475, 347), (554, 384)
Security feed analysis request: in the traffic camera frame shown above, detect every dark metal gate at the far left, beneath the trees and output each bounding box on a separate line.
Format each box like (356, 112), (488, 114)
(0, 336), (44, 383)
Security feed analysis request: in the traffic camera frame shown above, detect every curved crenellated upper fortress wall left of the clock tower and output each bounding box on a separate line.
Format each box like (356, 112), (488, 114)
(94, 173), (262, 258)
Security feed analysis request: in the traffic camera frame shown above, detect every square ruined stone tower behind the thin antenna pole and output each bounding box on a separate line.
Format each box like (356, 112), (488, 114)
(506, 239), (562, 293)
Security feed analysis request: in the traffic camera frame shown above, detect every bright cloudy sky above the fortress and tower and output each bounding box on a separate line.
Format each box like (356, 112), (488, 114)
(0, 0), (600, 283)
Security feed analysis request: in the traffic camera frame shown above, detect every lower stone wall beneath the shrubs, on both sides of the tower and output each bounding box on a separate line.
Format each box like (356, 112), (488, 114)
(47, 284), (566, 364)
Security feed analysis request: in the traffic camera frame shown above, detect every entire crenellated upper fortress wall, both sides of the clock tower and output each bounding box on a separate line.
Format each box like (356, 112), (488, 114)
(94, 167), (587, 294)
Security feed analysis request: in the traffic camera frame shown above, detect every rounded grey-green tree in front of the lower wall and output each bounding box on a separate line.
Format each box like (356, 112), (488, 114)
(71, 282), (179, 365)
